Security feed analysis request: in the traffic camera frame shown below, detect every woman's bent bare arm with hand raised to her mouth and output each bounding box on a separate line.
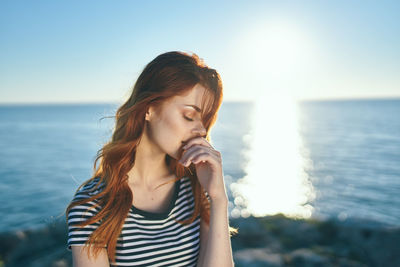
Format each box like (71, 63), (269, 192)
(179, 136), (234, 267)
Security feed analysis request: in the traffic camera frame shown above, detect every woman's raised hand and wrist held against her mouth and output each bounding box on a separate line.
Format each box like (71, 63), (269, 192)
(179, 137), (228, 201)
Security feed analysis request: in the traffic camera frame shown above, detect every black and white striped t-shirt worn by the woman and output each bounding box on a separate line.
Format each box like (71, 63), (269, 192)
(67, 177), (200, 266)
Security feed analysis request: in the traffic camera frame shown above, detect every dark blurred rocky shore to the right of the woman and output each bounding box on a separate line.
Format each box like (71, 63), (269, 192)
(231, 215), (400, 267)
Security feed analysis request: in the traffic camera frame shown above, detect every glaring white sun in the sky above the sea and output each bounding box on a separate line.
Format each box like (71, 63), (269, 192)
(236, 21), (314, 79)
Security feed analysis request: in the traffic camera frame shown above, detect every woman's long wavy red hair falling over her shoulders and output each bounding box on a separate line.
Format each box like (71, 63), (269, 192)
(66, 51), (236, 262)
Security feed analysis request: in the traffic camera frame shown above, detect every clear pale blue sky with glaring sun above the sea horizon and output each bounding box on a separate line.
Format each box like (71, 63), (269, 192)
(0, 0), (400, 104)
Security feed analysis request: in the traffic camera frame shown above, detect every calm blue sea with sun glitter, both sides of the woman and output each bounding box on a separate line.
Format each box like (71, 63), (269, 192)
(0, 99), (400, 232)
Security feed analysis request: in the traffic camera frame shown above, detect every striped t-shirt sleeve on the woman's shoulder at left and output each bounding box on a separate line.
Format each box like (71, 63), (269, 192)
(67, 180), (104, 251)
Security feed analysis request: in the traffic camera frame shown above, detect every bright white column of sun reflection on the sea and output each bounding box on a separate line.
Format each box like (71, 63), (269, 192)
(231, 95), (315, 218)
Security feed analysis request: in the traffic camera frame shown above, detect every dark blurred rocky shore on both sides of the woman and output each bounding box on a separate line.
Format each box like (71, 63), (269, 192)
(0, 215), (400, 267)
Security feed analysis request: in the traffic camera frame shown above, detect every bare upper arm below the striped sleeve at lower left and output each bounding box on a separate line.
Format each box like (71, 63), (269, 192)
(71, 246), (110, 267)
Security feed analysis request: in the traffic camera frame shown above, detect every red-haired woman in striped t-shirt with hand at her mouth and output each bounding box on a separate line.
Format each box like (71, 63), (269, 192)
(66, 51), (236, 267)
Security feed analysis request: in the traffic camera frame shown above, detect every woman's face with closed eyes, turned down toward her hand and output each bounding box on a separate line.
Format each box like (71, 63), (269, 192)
(146, 84), (206, 159)
